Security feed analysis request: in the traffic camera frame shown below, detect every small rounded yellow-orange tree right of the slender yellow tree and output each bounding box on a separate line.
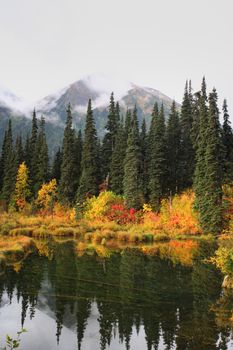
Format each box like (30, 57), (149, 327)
(36, 179), (57, 211)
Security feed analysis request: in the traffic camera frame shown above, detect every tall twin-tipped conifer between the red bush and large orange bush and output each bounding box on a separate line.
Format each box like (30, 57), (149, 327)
(149, 105), (166, 211)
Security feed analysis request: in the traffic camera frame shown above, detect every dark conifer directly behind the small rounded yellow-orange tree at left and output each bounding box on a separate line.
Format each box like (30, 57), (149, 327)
(34, 116), (49, 193)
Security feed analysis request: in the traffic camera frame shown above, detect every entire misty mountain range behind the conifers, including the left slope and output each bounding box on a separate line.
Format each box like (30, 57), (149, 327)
(0, 75), (179, 155)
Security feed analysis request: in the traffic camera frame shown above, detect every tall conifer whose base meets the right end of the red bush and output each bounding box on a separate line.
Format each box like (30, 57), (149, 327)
(123, 107), (144, 209)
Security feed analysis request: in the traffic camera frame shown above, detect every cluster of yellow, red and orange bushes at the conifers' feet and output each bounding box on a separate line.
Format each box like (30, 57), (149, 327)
(80, 191), (200, 235)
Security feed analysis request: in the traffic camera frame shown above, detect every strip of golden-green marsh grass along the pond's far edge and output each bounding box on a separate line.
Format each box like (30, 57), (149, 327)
(0, 213), (208, 244)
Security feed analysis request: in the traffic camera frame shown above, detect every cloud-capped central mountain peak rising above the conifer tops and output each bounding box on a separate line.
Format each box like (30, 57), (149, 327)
(36, 76), (179, 136)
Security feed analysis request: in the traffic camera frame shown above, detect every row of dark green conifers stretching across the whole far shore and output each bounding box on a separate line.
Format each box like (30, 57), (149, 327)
(0, 78), (233, 233)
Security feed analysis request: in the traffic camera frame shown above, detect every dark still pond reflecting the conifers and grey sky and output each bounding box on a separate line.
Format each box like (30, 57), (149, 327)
(0, 241), (233, 350)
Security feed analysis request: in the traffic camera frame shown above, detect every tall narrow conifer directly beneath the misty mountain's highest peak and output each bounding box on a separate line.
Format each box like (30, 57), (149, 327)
(77, 100), (99, 203)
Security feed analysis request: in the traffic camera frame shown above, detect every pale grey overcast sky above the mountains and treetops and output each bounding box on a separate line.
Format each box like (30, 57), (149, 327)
(0, 0), (233, 119)
